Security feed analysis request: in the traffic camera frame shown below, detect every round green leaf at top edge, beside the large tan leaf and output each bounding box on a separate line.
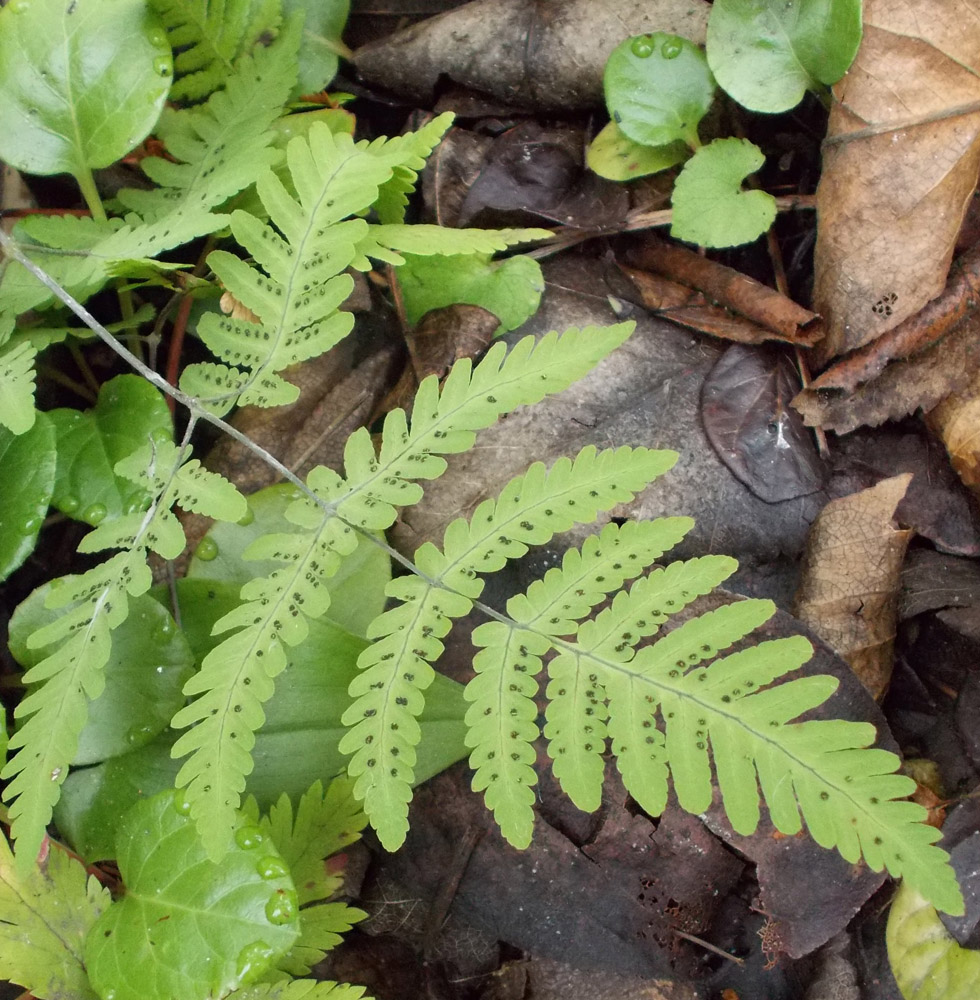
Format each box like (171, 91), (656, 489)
(707, 0), (861, 112)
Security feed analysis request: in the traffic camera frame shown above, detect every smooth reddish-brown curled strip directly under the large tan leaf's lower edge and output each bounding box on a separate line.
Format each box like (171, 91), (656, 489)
(810, 246), (980, 389)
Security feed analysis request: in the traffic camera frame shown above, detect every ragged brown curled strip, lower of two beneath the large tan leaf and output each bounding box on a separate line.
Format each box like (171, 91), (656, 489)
(792, 313), (980, 434)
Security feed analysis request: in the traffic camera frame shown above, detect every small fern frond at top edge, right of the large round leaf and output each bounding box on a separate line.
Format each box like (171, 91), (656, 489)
(150, 0), (280, 101)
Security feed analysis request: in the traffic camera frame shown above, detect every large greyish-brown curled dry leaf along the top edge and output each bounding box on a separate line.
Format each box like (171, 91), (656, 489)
(354, 0), (711, 112)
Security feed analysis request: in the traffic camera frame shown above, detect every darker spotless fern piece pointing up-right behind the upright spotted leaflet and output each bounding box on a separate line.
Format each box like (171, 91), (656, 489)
(118, 30), (299, 224)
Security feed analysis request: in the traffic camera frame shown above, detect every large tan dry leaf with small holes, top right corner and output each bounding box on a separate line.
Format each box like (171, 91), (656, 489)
(814, 0), (980, 358)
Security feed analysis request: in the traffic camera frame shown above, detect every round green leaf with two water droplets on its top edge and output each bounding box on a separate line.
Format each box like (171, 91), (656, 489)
(603, 32), (715, 149)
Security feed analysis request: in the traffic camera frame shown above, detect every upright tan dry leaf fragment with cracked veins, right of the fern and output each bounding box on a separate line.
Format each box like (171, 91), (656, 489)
(795, 473), (912, 698)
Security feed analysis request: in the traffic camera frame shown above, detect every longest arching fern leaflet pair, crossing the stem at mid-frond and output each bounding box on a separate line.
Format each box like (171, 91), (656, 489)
(173, 323), (632, 856)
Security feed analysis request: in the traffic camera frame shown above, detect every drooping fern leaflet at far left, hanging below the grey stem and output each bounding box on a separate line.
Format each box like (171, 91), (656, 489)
(0, 442), (247, 866)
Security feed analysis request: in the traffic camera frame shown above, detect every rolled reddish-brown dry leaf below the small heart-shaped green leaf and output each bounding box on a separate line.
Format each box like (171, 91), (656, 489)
(630, 238), (822, 347)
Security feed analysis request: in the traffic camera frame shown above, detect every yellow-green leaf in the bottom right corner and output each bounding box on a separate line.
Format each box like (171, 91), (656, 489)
(885, 884), (980, 1000)
